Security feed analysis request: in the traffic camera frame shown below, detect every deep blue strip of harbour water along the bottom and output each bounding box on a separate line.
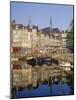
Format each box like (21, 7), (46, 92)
(16, 82), (73, 98)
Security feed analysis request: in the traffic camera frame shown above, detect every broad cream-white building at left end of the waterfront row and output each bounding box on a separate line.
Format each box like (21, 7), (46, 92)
(12, 25), (31, 48)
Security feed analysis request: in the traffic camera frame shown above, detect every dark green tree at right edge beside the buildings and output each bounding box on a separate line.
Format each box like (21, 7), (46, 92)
(66, 20), (74, 52)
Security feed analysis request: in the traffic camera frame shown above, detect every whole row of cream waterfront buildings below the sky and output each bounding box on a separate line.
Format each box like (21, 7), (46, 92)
(11, 22), (67, 53)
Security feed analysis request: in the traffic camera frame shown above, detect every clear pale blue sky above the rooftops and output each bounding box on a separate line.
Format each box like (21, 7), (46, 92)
(11, 2), (73, 30)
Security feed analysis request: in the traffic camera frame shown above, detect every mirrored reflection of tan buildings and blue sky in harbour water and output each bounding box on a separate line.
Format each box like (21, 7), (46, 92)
(12, 63), (74, 98)
